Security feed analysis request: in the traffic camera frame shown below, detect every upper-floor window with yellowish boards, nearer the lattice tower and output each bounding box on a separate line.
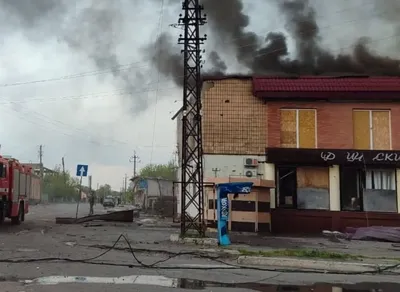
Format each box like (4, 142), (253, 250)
(281, 109), (317, 148)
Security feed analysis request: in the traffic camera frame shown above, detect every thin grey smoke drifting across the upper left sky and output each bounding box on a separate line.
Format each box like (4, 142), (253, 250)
(0, 0), (152, 112)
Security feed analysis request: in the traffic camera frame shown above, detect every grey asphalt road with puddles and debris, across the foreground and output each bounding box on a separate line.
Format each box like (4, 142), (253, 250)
(0, 204), (400, 292)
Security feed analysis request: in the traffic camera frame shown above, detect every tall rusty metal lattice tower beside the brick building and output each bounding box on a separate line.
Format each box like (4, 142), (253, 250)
(178, 0), (208, 236)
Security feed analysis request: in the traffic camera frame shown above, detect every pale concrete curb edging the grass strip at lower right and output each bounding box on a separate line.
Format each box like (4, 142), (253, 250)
(237, 256), (400, 273)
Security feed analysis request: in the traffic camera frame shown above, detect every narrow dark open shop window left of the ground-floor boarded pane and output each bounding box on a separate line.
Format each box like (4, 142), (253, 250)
(277, 167), (297, 208)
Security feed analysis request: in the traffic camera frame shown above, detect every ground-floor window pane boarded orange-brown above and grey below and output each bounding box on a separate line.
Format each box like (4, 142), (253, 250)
(297, 167), (329, 210)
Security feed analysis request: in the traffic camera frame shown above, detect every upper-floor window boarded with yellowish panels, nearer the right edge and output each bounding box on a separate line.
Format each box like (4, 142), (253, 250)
(353, 110), (391, 150)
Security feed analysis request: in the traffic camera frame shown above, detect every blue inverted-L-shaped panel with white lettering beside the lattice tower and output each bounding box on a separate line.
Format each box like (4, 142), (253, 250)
(216, 182), (253, 246)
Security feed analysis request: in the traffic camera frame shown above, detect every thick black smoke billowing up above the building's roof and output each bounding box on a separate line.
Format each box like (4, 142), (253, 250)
(147, 0), (400, 84)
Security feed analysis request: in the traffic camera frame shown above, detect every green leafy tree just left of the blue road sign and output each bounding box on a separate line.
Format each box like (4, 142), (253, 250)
(43, 166), (79, 201)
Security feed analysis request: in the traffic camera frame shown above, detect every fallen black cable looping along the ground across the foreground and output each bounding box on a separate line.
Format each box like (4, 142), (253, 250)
(0, 234), (400, 275)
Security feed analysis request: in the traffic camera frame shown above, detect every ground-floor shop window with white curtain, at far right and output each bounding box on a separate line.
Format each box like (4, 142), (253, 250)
(340, 168), (397, 212)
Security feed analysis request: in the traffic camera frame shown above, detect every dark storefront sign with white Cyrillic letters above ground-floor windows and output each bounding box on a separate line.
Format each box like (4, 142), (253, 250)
(267, 148), (400, 166)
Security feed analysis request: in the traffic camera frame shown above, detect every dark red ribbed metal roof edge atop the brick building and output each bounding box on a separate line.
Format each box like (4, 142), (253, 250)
(253, 76), (400, 101)
